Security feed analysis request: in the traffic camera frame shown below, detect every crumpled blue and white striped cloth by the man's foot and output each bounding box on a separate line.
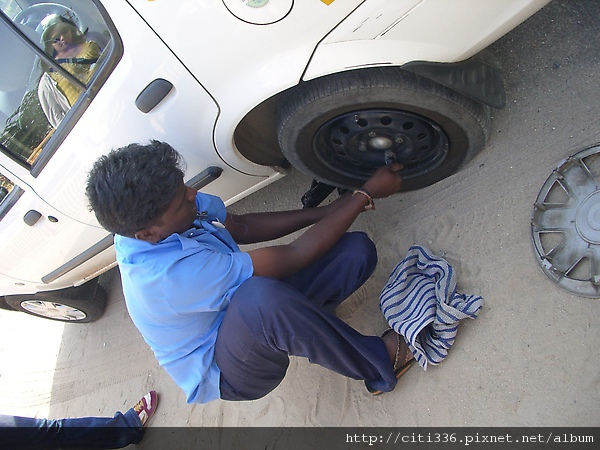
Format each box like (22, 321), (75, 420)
(379, 245), (483, 370)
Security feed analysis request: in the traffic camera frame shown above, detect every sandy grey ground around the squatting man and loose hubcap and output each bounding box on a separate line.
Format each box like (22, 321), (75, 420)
(0, 0), (600, 442)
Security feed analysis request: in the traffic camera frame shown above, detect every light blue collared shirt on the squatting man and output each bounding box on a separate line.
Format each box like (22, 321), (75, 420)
(115, 193), (253, 403)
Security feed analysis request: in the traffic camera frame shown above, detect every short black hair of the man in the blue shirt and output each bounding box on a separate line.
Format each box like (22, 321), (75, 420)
(86, 140), (185, 237)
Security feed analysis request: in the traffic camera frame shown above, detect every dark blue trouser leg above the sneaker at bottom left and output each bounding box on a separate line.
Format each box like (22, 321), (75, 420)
(0, 408), (144, 450)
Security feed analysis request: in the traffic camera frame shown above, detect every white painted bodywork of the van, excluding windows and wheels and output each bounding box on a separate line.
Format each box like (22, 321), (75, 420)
(0, 0), (549, 320)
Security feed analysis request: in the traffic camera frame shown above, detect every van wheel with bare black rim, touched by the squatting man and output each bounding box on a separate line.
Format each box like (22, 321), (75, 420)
(278, 67), (491, 191)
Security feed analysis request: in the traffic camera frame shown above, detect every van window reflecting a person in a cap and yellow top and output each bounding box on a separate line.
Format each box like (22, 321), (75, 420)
(0, 0), (114, 168)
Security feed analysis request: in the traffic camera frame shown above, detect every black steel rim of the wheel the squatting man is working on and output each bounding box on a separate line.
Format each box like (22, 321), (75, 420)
(313, 109), (449, 179)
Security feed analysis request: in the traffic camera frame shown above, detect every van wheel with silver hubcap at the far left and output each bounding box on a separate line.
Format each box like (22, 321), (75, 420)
(5, 279), (106, 323)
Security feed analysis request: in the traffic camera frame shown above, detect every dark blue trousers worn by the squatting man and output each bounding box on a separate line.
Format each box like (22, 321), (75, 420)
(215, 232), (396, 400)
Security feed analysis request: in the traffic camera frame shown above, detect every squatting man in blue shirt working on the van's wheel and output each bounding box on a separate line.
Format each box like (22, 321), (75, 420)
(86, 141), (414, 403)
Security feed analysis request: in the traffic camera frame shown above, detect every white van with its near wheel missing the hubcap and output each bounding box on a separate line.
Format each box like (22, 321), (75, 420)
(0, 0), (549, 322)
